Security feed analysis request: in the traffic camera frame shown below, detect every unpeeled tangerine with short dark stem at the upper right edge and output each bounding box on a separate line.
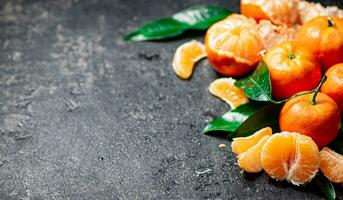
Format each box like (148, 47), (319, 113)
(296, 16), (343, 72)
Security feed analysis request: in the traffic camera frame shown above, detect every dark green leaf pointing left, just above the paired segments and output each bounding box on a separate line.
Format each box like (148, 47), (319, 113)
(203, 102), (282, 139)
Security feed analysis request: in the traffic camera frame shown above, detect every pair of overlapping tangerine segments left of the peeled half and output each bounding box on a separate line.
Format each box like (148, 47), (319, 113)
(231, 127), (272, 173)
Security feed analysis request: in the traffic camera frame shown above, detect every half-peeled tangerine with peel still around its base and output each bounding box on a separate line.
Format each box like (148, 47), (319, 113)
(205, 14), (263, 76)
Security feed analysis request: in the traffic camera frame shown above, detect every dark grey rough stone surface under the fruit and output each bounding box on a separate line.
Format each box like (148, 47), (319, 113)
(0, 0), (342, 199)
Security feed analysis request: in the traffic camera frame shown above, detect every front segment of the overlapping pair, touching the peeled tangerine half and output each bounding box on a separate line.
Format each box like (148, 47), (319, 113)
(237, 135), (270, 173)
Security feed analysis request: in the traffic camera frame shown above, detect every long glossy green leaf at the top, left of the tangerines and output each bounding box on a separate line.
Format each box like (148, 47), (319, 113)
(124, 5), (231, 41)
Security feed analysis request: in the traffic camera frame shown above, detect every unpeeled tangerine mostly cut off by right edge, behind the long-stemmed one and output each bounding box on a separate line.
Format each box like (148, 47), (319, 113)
(320, 63), (343, 112)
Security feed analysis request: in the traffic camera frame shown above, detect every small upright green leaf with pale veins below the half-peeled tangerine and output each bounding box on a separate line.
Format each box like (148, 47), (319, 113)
(235, 62), (274, 102)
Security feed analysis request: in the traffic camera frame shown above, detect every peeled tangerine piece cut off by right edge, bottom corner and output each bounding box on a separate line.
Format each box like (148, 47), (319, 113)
(320, 147), (343, 184)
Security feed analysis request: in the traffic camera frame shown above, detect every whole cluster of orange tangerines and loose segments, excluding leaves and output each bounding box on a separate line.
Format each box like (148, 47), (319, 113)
(173, 0), (343, 185)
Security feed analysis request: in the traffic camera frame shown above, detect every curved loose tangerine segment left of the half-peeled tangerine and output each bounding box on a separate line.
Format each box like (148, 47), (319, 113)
(173, 40), (206, 79)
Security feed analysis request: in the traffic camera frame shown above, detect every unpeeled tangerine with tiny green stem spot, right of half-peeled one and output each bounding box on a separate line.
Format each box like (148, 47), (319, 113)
(263, 41), (322, 99)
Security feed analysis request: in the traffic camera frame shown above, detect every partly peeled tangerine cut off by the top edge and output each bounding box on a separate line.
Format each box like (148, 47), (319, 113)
(241, 0), (298, 25)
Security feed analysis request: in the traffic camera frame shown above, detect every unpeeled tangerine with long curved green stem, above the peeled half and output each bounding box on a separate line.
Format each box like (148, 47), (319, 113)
(279, 92), (341, 148)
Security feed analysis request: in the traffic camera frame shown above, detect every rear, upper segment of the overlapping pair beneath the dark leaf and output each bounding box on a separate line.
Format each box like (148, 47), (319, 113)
(231, 127), (273, 155)
